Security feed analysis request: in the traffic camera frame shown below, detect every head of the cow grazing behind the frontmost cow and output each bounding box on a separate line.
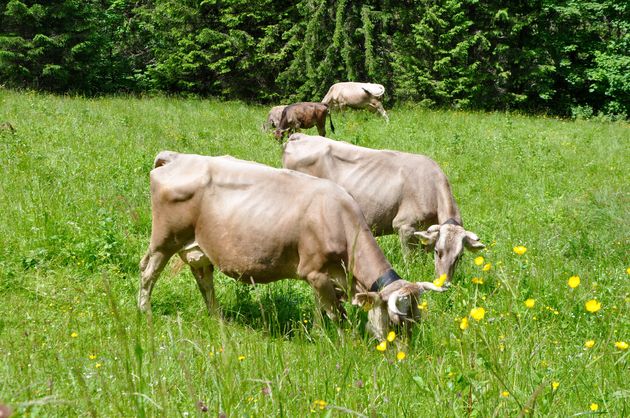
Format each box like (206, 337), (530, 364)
(415, 221), (485, 283)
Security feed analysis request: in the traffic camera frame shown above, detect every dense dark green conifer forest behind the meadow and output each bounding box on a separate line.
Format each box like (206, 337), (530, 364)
(0, 0), (630, 118)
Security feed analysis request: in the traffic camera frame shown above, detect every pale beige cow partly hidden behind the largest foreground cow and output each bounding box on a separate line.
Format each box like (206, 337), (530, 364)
(282, 134), (484, 283)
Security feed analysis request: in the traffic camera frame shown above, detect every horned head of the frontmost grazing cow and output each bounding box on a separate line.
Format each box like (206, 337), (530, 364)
(352, 280), (446, 340)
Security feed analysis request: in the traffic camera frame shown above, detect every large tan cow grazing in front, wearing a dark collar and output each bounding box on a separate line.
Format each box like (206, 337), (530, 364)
(138, 151), (444, 338)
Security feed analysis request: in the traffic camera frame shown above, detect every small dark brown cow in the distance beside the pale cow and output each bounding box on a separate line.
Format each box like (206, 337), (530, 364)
(275, 102), (335, 141)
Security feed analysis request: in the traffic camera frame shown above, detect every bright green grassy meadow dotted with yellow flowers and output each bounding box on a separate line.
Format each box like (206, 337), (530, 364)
(0, 90), (630, 417)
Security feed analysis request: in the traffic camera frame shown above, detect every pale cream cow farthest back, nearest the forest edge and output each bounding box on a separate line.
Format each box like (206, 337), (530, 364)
(322, 81), (389, 122)
